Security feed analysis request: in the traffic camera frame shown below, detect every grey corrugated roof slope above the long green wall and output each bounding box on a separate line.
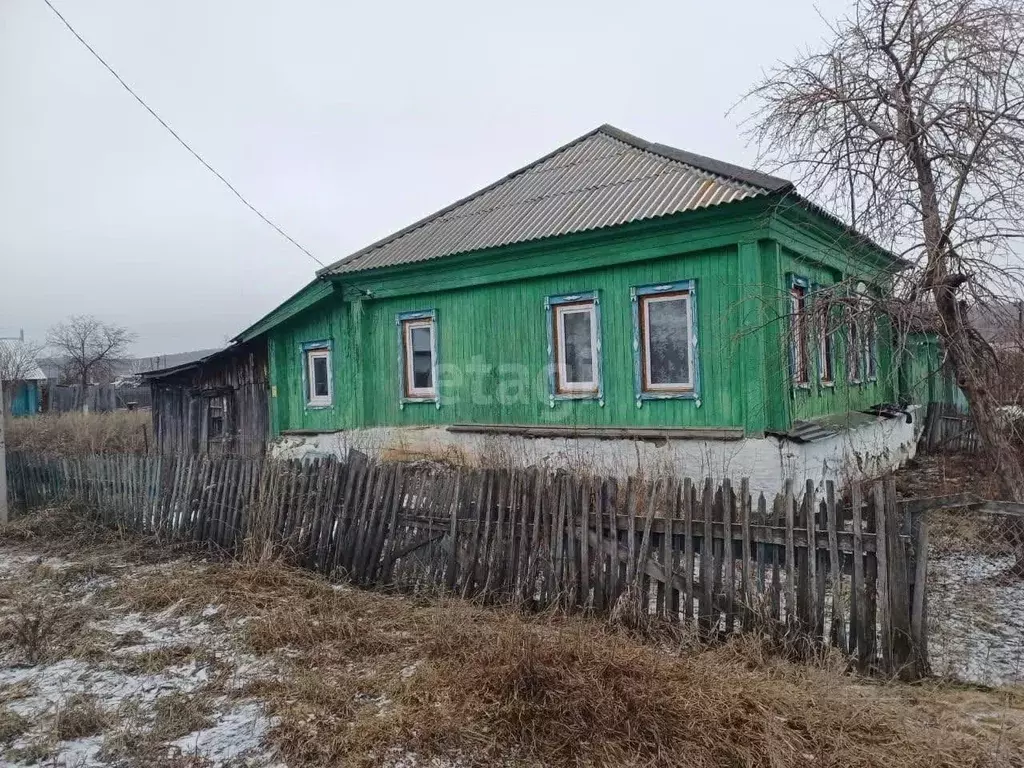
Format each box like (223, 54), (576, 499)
(321, 125), (793, 274)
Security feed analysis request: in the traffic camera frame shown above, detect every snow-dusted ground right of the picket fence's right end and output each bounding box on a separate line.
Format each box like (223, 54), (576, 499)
(928, 553), (1024, 685)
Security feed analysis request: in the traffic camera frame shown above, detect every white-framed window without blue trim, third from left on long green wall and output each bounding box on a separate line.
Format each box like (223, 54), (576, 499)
(549, 299), (600, 395)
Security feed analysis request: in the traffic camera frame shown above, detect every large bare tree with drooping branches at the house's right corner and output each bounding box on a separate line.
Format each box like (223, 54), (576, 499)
(743, 0), (1024, 500)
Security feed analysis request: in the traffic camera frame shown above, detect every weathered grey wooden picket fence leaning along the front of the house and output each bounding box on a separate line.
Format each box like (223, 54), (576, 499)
(7, 453), (928, 677)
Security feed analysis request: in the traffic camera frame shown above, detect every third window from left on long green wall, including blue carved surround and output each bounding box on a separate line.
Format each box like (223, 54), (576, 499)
(545, 292), (601, 399)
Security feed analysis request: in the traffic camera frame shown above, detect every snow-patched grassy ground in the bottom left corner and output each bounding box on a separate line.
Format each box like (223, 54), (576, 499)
(0, 548), (281, 768)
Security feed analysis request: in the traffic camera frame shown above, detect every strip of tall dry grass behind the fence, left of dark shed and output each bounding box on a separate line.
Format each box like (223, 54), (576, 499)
(6, 411), (153, 456)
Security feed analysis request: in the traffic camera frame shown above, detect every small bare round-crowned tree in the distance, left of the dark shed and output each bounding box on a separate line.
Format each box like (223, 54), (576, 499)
(46, 314), (135, 403)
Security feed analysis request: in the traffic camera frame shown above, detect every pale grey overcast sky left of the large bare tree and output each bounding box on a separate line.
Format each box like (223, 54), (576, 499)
(0, 0), (846, 354)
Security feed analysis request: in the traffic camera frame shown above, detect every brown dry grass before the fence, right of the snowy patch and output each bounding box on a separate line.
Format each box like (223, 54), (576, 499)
(112, 564), (1024, 768)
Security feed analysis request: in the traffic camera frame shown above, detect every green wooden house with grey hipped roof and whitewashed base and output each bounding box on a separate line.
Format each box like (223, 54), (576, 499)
(239, 125), (913, 487)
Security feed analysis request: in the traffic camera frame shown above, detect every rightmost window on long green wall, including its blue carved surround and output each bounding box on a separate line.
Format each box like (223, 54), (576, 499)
(634, 281), (697, 399)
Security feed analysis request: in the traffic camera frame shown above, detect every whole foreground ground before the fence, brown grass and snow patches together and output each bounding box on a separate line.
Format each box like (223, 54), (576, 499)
(0, 511), (1024, 768)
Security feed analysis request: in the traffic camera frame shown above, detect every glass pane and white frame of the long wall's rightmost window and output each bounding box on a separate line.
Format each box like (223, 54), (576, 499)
(644, 294), (691, 387)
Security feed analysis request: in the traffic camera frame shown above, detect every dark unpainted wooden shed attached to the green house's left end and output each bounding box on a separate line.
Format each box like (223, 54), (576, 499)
(143, 337), (269, 456)
